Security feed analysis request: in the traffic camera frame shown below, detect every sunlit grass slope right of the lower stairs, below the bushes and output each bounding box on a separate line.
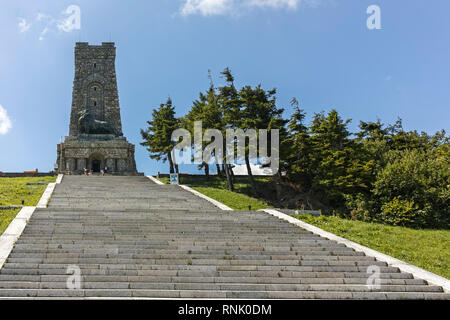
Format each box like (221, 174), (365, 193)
(294, 215), (450, 279)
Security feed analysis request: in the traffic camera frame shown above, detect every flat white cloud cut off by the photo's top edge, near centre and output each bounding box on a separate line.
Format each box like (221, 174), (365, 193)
(180, 0), (324, 16)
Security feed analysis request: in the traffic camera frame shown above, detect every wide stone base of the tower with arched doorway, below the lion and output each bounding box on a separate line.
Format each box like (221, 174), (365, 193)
(55, 134), (142, 175)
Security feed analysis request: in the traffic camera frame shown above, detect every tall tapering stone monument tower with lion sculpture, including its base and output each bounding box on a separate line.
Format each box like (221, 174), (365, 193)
(55, 42), (137, 175)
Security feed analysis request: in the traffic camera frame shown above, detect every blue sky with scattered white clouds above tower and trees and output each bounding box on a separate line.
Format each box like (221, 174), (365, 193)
(0, 0), (450, 174)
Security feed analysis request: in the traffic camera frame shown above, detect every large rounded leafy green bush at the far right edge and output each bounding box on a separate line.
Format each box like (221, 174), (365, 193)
(373, 149), (450, 228)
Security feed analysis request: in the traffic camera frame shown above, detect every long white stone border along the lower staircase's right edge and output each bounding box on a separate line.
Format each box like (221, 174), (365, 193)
(260, 209), (450, 293)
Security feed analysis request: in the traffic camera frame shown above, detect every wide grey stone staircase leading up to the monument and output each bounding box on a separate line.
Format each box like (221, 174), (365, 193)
(0, 176), (450, 299)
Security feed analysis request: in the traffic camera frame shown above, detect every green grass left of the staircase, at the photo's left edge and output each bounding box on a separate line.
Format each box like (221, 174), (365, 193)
(0, 177), (56, 234)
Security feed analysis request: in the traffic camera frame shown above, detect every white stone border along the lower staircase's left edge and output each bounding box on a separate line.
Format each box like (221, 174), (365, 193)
(0, 207), (36, 269)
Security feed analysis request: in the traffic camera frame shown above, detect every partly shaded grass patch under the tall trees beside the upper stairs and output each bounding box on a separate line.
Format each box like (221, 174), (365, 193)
(159, 176), (271, 210)
